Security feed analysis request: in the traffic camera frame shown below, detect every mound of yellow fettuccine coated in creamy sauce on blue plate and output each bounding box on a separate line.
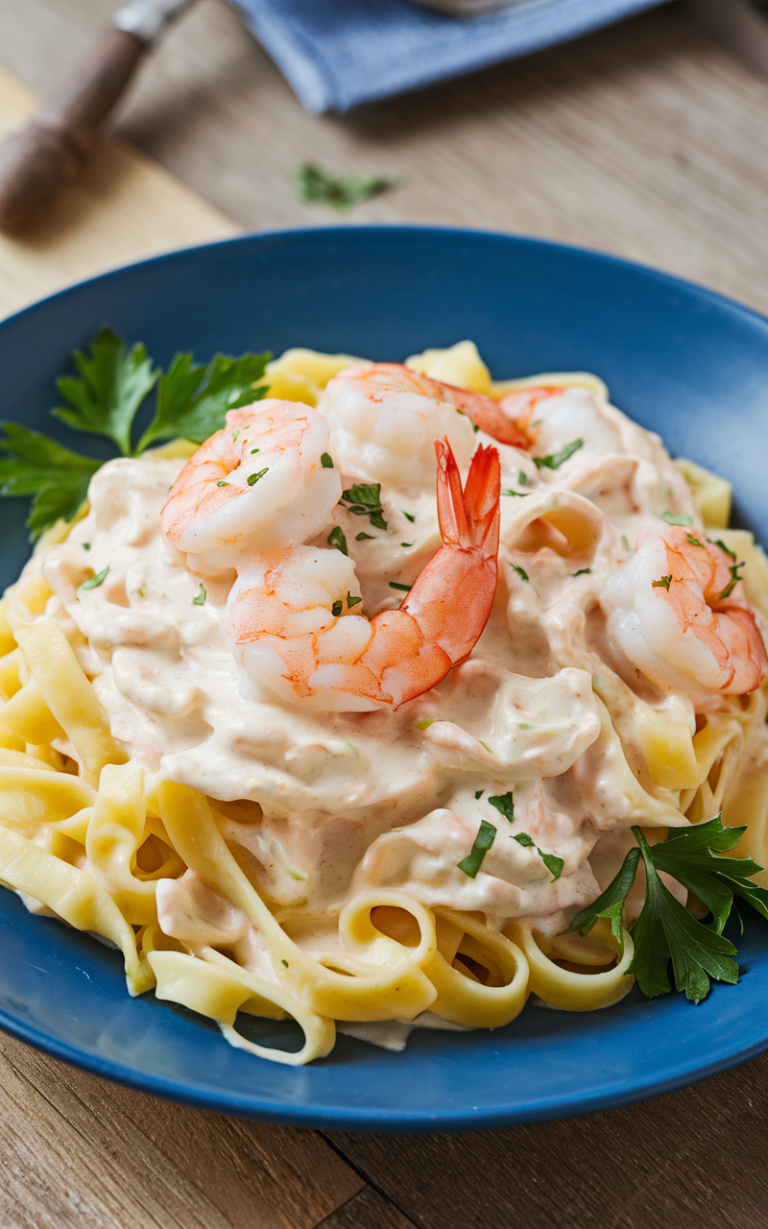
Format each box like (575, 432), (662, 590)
(0, 342), (768, 1066)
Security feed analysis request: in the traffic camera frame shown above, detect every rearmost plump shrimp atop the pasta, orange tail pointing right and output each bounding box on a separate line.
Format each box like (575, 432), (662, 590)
(317, 363), (526, 489)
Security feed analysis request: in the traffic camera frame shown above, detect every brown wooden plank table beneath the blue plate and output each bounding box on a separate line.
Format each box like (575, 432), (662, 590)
(0, 0), (768, 1229)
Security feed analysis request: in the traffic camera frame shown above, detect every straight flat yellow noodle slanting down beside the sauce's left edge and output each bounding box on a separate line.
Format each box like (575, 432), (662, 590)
(14, 619), (125, 773)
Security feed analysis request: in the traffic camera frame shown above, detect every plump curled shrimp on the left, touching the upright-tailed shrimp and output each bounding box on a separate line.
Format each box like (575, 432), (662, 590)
(160, 399), (342, 575)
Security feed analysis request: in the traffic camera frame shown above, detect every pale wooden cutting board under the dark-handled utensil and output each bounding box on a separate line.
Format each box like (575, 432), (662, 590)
(0, 69), (238, 317)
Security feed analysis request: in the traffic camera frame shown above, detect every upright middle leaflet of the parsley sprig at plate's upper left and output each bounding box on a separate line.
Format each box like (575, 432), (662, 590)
(53, 328), (162, 457)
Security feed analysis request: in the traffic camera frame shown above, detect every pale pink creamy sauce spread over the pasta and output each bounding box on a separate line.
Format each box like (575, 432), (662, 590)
(43, 390), (698, 929)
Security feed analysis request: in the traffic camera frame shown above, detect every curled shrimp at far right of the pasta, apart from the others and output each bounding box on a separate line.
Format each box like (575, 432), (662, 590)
(602, 526), (768, 703)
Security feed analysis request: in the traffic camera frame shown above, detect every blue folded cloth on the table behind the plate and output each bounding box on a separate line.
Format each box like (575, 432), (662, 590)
(236, 0), (664, 113)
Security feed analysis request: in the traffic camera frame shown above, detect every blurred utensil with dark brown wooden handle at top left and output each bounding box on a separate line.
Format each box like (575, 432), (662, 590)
(0, 0), (193, 231)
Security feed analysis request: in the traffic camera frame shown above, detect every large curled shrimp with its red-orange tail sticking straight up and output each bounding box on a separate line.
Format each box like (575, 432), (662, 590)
(225, 440), (500, 712)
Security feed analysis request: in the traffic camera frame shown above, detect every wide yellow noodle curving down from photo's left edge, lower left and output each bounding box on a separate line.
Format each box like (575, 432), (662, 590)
(0, 828), (155, 995)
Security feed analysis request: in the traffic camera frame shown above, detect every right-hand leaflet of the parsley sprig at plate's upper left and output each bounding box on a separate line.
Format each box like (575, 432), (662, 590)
(136, 354), (270, 454)
